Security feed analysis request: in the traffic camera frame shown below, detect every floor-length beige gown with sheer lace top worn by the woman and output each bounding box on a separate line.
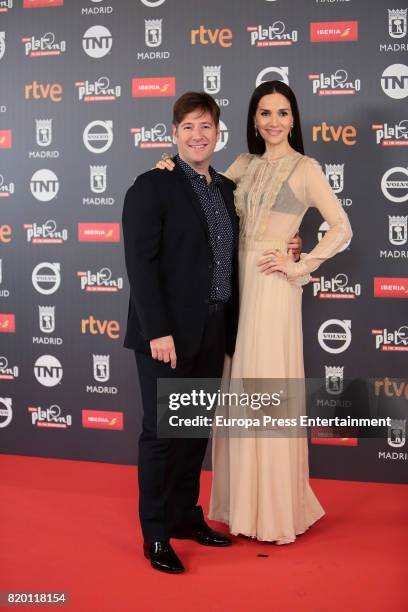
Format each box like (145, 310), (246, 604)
(209, 153), (351, 544)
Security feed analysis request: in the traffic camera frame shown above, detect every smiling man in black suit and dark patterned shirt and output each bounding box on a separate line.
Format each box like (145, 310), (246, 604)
(123, 92), (238, 573)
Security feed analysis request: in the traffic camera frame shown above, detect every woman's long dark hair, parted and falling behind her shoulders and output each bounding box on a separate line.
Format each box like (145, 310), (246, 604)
(247, 81), (304, 155)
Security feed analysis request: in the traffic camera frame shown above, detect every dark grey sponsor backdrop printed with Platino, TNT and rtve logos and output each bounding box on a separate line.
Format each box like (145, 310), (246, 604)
(0, 0), (408, 482)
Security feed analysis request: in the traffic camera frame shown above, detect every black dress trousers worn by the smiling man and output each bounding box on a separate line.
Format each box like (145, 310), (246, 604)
(135, 305), (225, 543)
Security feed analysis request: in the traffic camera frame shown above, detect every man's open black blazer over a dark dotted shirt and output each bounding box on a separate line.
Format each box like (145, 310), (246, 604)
(122, 164), (239, 358)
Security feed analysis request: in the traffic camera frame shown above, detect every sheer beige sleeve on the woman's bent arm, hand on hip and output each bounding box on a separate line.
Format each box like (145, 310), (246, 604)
(287, 158), (353, 280)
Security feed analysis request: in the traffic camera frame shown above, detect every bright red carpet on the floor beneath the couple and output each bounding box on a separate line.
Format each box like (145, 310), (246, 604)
(0, 455), (408, 612)
